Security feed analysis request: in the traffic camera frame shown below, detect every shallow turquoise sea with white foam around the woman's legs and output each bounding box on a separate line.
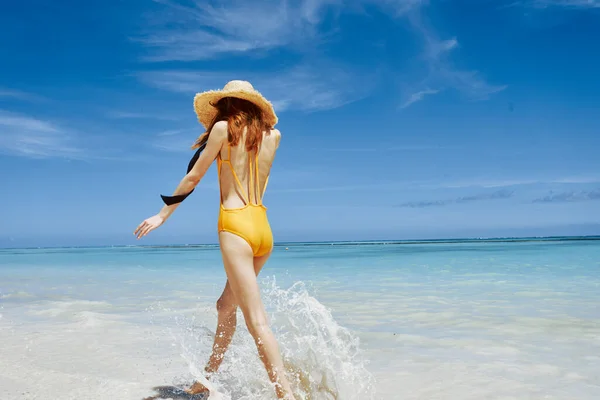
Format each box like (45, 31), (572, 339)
(0, 238), (600, 400)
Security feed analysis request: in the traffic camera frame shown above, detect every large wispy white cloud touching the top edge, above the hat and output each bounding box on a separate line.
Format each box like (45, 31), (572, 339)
(134, 0), (423, 62)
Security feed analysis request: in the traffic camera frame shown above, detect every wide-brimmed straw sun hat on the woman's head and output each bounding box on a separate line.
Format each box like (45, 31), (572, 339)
(194, 80), (277, 128)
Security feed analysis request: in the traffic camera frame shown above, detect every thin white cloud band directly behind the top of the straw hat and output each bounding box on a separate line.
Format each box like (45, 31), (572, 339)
(136, 64), (375, 111)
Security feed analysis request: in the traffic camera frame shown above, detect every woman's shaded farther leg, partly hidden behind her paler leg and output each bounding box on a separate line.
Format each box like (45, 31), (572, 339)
(187, 245), (271, 394)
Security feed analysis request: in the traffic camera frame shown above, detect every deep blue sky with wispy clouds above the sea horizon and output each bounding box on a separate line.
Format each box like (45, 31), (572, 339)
(0, 0), (600, 246)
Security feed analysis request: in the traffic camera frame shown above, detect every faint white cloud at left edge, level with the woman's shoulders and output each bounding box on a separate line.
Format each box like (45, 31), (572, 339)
(0, 111), (82, 159)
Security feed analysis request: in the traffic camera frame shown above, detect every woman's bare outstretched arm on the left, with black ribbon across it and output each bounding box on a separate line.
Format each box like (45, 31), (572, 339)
(133, 121), (227, 239)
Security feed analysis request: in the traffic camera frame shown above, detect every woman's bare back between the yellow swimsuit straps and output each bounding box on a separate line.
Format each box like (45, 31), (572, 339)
(218, 129), (281, 209)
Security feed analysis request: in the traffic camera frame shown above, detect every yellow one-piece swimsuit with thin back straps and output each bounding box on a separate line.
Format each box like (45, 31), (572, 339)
(217, 145), (273, 257)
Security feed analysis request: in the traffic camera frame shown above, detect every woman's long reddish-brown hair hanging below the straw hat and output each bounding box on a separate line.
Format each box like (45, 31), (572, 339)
(192, 97), (272, 151)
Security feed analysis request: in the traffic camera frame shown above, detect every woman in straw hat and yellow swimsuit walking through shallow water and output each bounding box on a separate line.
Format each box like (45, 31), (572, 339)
(134, 81), (294, 399)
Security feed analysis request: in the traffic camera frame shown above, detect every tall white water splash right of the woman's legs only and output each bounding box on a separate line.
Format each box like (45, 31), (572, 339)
(263, 279), (375, 400)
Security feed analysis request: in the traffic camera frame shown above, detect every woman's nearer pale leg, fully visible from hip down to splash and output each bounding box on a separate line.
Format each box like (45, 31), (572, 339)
(219, 232), (294, 400)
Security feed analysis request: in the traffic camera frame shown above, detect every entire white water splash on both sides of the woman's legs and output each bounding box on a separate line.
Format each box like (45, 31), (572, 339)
(150, 278), (376, 400)
